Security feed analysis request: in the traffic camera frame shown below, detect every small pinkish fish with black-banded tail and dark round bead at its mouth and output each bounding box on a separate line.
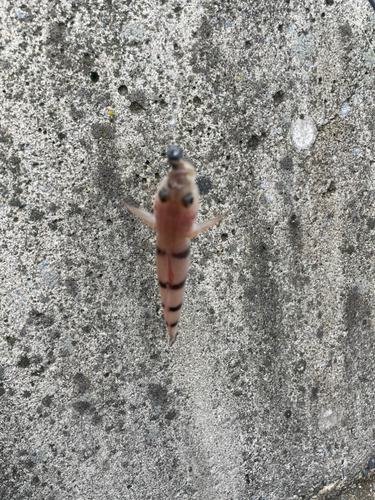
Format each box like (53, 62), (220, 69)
(124, 146), (227, 346)
